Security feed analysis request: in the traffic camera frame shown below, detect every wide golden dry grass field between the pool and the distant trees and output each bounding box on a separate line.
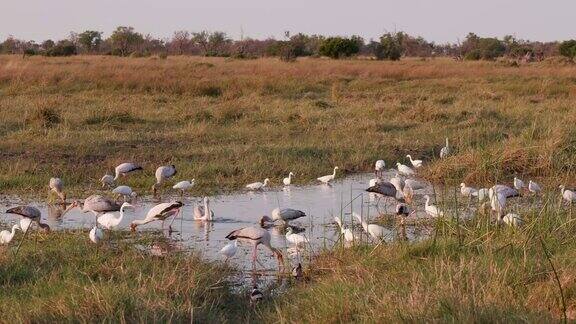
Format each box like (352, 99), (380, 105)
(0, 56), (576, 194)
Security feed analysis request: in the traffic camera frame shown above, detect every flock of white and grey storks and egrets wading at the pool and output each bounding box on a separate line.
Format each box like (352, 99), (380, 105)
(0, 135), (576, 290)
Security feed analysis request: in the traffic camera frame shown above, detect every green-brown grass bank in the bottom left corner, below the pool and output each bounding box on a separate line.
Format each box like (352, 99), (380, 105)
(0, 231), (246, 323)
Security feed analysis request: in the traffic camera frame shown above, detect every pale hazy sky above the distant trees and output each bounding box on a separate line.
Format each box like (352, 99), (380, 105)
(0, 0), (576, 43)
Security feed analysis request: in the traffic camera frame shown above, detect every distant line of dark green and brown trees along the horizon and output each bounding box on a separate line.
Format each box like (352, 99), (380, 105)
(0, 26), (576, 61)
